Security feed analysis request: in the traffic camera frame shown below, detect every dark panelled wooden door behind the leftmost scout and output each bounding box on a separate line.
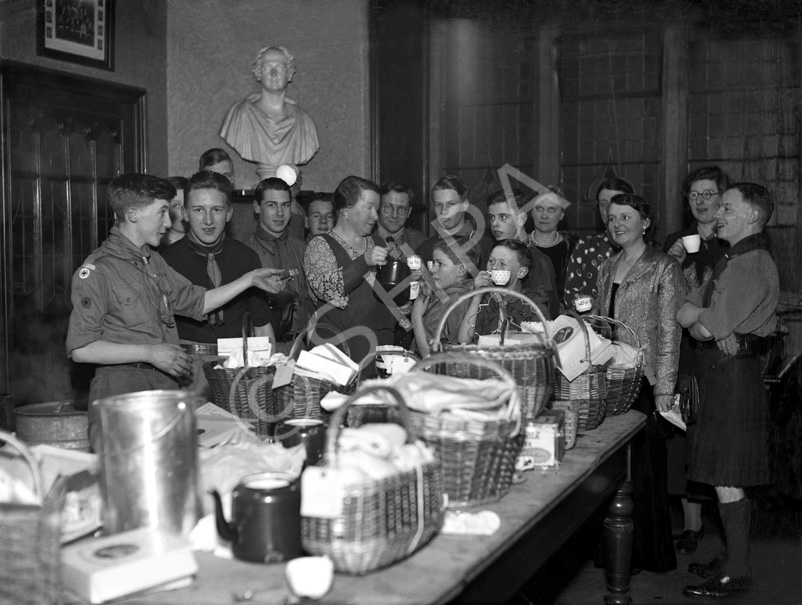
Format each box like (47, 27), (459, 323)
(0, 63), (146, 404)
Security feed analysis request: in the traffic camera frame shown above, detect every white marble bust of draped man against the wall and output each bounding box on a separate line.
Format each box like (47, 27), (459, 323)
(220, 46), (320, 180)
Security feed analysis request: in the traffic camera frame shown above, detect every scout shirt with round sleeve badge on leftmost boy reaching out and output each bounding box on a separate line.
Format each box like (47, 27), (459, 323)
(66, 227), (206, 355)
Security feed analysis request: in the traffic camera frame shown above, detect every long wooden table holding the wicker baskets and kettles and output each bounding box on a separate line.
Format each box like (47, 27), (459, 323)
(76, 411), (645, 605)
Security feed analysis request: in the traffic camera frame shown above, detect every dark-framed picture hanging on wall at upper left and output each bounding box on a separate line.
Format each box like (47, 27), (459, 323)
(36, 0), (116, 71)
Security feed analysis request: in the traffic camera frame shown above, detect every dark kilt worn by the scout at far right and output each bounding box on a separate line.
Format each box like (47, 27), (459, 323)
(688, 349), (770, 487)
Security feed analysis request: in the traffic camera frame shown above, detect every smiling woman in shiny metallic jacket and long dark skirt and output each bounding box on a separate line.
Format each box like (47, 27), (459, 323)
(596, 193), (684, 572)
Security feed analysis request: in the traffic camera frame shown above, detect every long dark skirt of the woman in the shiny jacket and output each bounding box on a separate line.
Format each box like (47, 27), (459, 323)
(631, 379), (677, 572)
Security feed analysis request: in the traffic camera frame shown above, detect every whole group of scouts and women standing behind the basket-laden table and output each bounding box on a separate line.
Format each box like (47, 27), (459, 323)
(67, 156), (779, 598)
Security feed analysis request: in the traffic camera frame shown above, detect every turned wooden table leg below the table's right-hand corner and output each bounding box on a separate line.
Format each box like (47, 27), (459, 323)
(604, 481), (633, 605)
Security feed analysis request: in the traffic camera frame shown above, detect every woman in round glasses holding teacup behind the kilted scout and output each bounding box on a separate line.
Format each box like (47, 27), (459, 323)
(663, 166), (729, 555)
